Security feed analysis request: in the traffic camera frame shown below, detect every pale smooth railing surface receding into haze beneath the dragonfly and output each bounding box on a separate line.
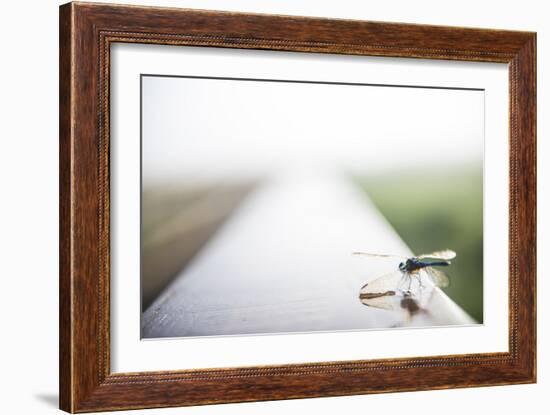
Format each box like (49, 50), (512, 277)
(142, 174), (474, 338)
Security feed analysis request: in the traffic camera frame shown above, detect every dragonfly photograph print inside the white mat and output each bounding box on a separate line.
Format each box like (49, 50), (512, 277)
(140, 74), (484, 339)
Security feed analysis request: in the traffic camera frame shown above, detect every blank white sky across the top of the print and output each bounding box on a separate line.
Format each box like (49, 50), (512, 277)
(142, 76), (484, 185)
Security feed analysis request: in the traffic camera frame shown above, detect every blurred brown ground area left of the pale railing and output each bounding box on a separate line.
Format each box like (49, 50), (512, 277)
(141, 183), (253, 309)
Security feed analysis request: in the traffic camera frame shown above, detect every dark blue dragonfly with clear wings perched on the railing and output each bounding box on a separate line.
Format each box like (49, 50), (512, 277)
(353, 249), (456, 310)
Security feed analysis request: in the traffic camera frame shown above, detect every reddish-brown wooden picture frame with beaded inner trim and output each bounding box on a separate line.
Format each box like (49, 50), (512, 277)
(59, 3), (536, 412)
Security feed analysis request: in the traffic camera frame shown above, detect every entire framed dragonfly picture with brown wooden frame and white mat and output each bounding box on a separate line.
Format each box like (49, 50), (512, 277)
(60, 3), (536, 412)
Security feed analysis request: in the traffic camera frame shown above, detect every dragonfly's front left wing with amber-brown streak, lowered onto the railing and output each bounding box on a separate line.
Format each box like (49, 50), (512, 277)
(359, 271), (405, 310)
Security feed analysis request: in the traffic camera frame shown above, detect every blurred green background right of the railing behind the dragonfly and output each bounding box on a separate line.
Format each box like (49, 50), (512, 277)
(356, 167), (483, 323)
